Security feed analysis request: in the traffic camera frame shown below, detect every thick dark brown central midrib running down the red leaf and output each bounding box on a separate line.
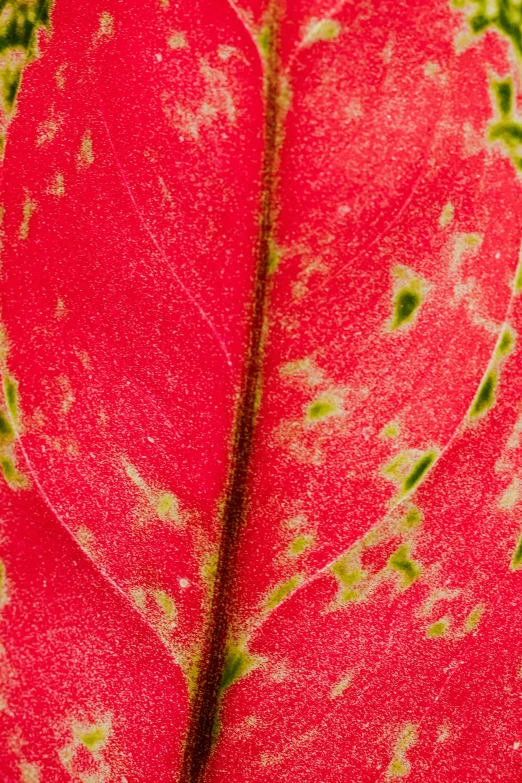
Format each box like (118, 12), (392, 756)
(180, 10), (281, 783)
